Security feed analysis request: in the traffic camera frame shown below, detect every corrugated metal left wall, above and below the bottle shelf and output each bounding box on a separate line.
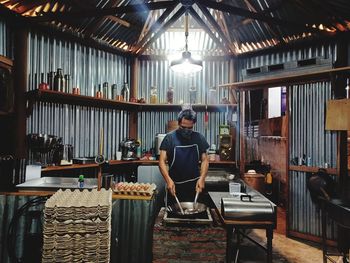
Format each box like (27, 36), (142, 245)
(27, 33), (130, 159)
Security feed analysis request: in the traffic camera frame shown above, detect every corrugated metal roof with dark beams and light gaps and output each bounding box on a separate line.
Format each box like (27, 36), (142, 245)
(0, 0), (350, 55)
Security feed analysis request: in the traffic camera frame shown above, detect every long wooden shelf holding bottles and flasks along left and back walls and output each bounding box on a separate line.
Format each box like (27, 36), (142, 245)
(26, 89), (237, 112)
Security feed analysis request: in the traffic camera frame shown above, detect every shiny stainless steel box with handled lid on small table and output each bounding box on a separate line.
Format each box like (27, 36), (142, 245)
(221, 194), (276, 221)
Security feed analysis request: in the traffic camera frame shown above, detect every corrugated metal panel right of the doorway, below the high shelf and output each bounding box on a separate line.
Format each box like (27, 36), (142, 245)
(289, 82), (337, 239)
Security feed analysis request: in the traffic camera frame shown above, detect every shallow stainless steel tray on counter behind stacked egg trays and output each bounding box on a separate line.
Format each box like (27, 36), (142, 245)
(16, 177), (97, 191)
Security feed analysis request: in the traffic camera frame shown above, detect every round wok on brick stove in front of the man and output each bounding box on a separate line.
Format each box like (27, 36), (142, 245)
(167, 202), (207, 218)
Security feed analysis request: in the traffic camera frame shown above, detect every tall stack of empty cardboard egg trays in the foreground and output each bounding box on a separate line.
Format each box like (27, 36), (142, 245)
(42, 189), (112, 263)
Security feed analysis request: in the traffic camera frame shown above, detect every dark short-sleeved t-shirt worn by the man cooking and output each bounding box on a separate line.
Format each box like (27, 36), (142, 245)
(159, 130), (209, 163)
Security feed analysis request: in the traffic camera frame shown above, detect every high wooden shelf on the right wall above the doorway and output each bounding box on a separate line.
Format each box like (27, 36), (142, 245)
(219, 67), (350, 90)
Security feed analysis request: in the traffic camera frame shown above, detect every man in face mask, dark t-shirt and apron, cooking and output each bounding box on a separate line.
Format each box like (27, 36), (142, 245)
(159, 109), (209, 206)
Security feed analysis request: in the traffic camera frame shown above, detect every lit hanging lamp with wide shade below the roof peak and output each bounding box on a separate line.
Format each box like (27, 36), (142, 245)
(170, 12), (203, 74)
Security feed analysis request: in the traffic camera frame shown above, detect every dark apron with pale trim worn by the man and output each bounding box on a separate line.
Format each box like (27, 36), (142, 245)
(165, 144), (200, 206)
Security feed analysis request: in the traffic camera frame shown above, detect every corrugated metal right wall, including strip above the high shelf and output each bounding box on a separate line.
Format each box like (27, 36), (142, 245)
(237, 44), (336, 239)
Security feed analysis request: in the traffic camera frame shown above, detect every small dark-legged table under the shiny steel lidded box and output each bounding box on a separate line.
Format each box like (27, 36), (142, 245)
(209, 192), (277, 263)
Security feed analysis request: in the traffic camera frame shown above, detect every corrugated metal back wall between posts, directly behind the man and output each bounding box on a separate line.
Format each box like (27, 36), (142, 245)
(138, 60), (234, 153)
